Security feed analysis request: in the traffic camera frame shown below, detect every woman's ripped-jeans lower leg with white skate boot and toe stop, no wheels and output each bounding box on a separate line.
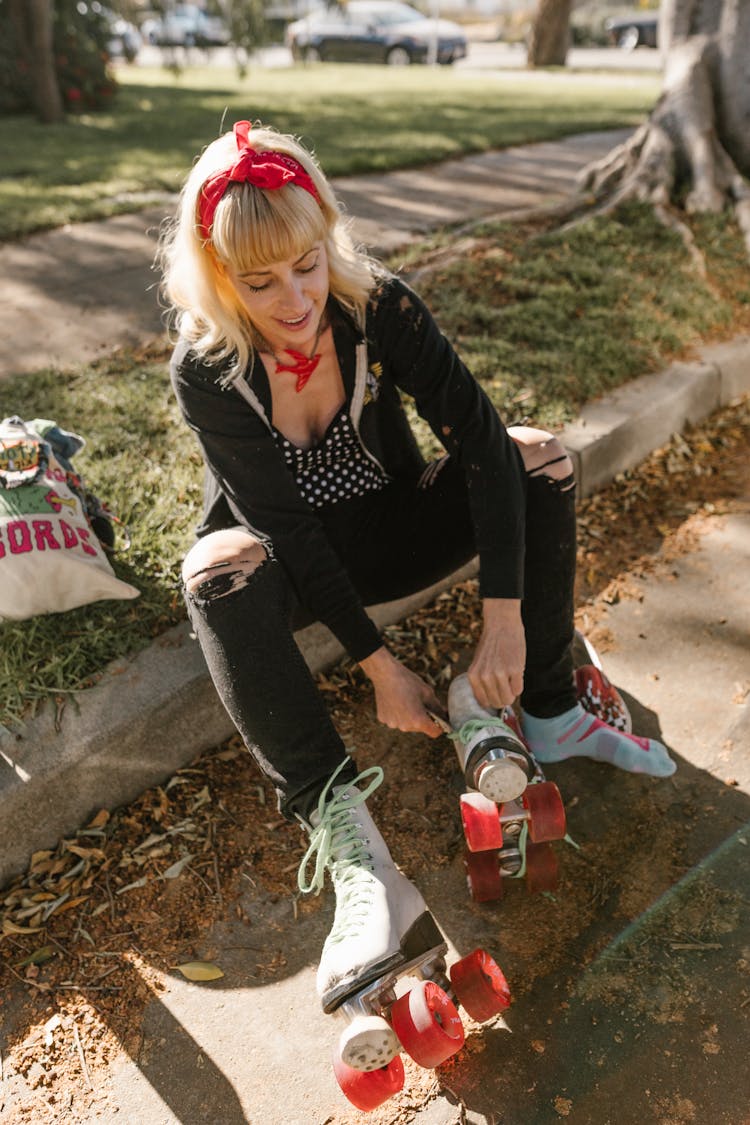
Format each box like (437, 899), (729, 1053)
(183, 528), (442, 1070)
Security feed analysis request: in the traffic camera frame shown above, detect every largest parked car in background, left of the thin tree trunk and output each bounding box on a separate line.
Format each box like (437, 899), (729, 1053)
(286, 0), (467, 66)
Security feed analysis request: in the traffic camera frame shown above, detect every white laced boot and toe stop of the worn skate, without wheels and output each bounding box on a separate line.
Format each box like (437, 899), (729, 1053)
(298, 763), (444, 1071)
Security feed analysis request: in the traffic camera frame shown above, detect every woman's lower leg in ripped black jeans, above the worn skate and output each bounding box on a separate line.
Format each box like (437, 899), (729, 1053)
(182, 528), (356, 817)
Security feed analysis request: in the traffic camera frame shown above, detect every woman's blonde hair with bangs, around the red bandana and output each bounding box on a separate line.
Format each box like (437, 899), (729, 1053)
(157, 127), (381, 380)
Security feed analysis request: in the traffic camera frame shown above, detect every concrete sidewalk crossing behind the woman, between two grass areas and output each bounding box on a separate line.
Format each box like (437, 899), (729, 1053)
(0, 131), (627, 378)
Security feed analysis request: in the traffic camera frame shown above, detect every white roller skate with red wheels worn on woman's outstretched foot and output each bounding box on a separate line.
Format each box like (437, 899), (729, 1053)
(298, 764), (509, 1110)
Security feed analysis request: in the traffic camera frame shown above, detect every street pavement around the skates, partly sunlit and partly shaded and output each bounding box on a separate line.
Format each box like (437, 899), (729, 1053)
(97, 510), (750, 1125)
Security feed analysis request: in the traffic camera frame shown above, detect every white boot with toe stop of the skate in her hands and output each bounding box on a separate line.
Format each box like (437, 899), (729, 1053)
(448, 674), (535, 804)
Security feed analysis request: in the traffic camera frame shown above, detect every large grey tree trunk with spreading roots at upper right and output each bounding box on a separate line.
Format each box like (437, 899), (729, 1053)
(582, 0), (750, 252)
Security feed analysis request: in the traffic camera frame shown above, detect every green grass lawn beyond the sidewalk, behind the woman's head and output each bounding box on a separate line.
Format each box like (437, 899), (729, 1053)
(0, 65), (660, 241)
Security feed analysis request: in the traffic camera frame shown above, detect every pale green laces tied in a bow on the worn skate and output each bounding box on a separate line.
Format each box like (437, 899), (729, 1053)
(297, 759), (383, 901)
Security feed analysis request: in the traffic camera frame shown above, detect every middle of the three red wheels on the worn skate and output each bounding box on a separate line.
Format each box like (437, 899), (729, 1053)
(390, 981), (463, 1067)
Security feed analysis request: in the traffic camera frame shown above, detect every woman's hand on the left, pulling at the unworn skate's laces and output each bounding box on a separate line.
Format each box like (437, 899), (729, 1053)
(360, 648), (445, 738)
